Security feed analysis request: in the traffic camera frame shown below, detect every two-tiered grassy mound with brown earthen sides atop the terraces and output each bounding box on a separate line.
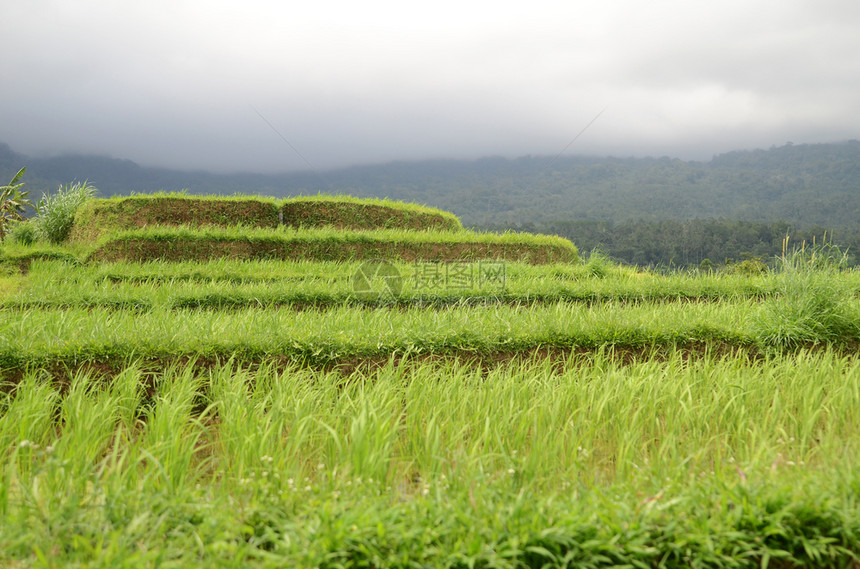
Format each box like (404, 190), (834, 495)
(65, 194), (578, 263)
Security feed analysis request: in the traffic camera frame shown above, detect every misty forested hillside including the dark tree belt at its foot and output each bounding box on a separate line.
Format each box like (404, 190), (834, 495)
(5, 141), (860, 265)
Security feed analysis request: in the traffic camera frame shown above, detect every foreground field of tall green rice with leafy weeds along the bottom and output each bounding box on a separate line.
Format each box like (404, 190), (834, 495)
(0, 352), (860, 567)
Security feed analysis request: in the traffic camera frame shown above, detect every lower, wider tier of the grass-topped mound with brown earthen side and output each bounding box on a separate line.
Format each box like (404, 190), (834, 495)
(89, 227), (579, 264)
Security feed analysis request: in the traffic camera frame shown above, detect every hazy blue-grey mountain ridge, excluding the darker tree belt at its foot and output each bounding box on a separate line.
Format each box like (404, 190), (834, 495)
(0, 140), (860, 228)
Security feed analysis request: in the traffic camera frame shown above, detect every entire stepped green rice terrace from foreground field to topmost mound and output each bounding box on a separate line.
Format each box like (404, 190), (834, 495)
(0, 184), (860, 568)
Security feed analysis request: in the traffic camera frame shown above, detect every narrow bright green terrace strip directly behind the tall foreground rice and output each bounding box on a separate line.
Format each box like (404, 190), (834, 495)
(0, 300), (858, 368)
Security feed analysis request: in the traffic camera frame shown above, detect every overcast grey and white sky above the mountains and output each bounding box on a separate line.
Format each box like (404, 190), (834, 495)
(0, 0), (860, 172)
